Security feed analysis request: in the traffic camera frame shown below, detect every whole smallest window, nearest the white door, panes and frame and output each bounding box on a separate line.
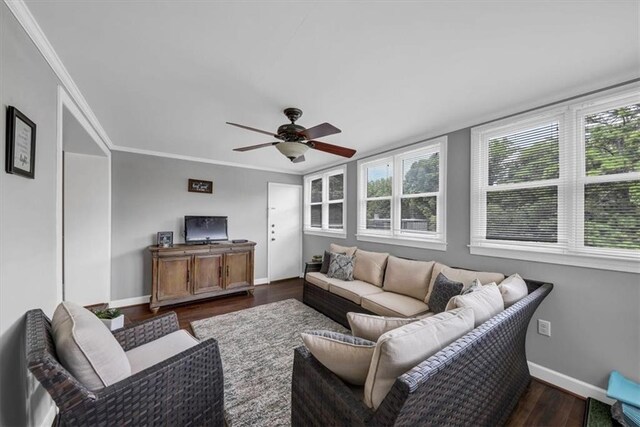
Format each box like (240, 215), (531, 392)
(304, 166), (346, 237)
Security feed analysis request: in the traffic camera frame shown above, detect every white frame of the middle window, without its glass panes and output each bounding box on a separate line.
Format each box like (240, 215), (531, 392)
(356, 136), (447, 251)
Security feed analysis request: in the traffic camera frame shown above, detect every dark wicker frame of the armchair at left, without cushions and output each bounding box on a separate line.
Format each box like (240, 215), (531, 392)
(26, 310), (224, 426)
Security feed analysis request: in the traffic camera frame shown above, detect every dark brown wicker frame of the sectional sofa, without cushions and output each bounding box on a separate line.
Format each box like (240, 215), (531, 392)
(291, 251), (553, 426)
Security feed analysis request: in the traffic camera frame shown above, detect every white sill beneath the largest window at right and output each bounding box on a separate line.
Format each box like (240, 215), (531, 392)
(469, 244), (640, 273)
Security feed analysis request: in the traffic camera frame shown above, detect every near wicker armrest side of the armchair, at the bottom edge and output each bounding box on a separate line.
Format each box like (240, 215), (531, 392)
(61, 339), (224, 426)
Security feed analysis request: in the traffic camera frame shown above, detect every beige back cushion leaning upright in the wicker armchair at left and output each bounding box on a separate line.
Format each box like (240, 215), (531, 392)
(51, 302), (131, 390)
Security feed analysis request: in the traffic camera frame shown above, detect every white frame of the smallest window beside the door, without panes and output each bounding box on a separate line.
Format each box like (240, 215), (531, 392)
(303, 165), (347, 239)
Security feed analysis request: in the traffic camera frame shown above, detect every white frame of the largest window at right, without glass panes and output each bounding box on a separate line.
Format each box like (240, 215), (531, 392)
(469, 85), (640, 273)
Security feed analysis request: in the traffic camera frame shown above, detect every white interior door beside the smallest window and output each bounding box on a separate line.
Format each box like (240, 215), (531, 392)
(267, 182), (302, 282)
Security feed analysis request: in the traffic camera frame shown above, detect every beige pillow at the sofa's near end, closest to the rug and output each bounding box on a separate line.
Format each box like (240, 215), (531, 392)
(301, 331), (376, 385)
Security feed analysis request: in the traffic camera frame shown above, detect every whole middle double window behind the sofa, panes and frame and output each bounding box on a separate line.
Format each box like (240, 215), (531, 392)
(357, 137), (447, 250)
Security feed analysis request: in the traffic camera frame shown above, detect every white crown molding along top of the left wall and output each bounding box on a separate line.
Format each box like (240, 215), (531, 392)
(4, 0), (114, 150)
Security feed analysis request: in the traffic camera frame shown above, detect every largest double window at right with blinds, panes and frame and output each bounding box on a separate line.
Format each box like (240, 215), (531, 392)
(470, 89), (640, 272)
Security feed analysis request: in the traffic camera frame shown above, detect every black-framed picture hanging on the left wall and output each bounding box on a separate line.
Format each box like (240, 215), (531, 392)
(6, 106), (36, 179)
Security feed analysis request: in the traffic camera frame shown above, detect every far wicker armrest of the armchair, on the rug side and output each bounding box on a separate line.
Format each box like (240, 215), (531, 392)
(113, 311), (180, 351)
